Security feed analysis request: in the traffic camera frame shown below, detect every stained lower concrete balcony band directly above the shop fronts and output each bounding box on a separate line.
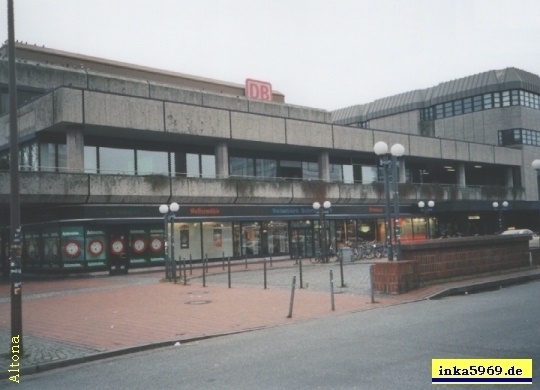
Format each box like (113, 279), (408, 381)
(0, 171), (526, 204)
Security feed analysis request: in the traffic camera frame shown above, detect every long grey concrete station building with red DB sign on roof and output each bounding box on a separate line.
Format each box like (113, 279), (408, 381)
(0, 43), (540, 272)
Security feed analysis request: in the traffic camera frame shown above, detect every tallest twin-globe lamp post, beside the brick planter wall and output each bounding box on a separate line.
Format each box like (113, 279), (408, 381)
(373, 141), (405, 261)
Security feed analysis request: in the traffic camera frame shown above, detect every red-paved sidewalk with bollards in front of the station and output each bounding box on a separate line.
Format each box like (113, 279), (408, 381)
(0, 260), (540, 379)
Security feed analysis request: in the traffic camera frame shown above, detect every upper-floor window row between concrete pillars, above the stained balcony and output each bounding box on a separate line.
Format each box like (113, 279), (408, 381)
(10, 142), (378, 184)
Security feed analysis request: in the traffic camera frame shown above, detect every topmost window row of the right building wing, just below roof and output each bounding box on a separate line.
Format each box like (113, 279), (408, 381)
(420, 89), (540, 121)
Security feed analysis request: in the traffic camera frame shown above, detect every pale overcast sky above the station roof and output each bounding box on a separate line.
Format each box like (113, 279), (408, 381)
(0, 0), (540, 111)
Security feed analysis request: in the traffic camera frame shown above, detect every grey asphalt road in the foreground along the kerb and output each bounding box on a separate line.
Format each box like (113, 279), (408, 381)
(5, 282), (540, 390)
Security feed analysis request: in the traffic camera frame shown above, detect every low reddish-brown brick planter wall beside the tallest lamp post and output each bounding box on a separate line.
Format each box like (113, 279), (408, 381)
(373, 236), (530, 294)
